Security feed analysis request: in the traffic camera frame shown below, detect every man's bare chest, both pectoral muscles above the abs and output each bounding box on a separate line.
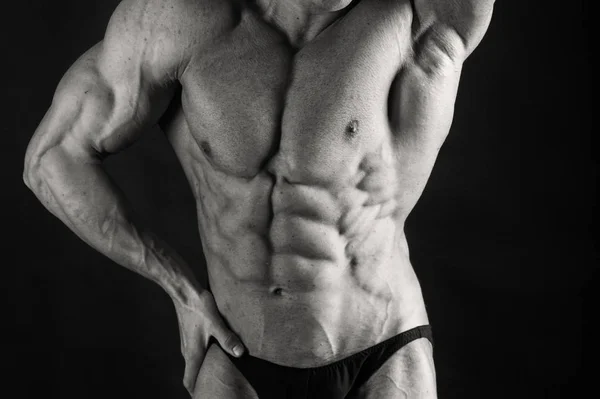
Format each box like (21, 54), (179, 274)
(176, 0), (410, 184)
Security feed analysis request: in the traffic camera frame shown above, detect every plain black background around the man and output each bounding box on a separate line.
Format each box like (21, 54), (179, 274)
(0, 0), (597, 399)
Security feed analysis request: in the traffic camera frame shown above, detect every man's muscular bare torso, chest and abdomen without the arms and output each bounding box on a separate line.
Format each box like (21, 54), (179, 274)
(163, 0), (427, 367)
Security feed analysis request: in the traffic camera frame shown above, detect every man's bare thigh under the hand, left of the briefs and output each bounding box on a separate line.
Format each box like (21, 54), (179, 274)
(194, 343), (258, 399)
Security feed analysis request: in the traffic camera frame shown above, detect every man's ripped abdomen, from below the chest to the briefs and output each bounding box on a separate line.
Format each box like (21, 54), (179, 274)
(199, 166), (427, 367)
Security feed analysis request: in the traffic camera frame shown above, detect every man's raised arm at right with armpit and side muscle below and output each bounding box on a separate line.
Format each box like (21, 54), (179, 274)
(392, 0), (494, 217)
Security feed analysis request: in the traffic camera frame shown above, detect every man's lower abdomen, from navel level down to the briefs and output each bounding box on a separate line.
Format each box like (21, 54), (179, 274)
(209, 256), (428, 367)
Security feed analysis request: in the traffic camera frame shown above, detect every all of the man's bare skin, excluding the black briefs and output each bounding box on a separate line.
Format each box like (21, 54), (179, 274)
(24, 0), (494, 399)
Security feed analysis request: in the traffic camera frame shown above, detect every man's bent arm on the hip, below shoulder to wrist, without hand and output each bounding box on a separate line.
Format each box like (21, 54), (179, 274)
(24, 0), (190, 310)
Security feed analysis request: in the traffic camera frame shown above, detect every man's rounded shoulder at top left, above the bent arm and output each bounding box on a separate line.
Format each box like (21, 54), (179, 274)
(102, 0), (235, 79)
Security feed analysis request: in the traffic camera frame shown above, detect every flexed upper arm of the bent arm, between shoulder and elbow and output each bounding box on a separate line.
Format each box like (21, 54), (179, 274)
(28, 2), (176, 166)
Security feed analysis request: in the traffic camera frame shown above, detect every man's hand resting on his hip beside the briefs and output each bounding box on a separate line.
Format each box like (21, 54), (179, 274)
(174, 290), (244, 395)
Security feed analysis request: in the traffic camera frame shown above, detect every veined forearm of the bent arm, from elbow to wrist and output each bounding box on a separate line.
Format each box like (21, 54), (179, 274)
(25, 144), (201, 303)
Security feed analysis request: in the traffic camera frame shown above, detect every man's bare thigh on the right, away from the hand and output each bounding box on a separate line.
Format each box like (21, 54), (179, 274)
(349, 338), (437, 399)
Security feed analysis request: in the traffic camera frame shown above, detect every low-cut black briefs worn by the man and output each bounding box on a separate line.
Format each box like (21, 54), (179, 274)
(224, 325), (433, 399)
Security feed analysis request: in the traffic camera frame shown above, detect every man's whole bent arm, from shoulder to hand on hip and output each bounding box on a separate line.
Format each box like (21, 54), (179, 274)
(24, 0), (244, 389)
